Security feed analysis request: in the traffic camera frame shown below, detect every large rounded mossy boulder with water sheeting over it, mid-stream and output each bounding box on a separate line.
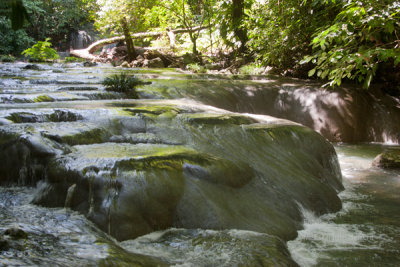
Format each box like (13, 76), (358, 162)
(0, 100), (341, 243)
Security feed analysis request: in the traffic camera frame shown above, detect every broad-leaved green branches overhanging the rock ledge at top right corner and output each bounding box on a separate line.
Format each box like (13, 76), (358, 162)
(302, 0), (400, 88)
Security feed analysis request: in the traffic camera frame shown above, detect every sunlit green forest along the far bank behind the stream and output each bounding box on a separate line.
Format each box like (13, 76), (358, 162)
(0, 0), (400, 90)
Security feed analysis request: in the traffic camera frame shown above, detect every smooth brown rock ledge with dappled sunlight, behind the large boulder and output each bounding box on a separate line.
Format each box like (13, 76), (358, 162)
(141, 78), (400, 143)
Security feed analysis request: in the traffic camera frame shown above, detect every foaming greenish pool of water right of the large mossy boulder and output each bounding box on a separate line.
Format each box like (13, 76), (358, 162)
(288, 144), (400, 266)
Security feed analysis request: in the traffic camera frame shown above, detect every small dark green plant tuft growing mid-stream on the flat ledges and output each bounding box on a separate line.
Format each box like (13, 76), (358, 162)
(102, 73), (143, 98)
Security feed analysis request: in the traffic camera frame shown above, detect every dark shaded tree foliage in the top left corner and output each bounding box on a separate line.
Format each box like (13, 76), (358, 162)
(0, 0), (97, 55)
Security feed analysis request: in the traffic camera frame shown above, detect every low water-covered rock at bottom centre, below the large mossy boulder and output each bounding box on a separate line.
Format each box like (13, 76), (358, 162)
(121, 228), (292, 267)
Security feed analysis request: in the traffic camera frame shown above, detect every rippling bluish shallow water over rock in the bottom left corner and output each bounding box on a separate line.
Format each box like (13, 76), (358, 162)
(0, 187), (167, 266)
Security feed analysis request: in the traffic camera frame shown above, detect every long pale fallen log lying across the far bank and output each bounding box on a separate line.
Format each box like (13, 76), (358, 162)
(70, 26), (208, 60)
